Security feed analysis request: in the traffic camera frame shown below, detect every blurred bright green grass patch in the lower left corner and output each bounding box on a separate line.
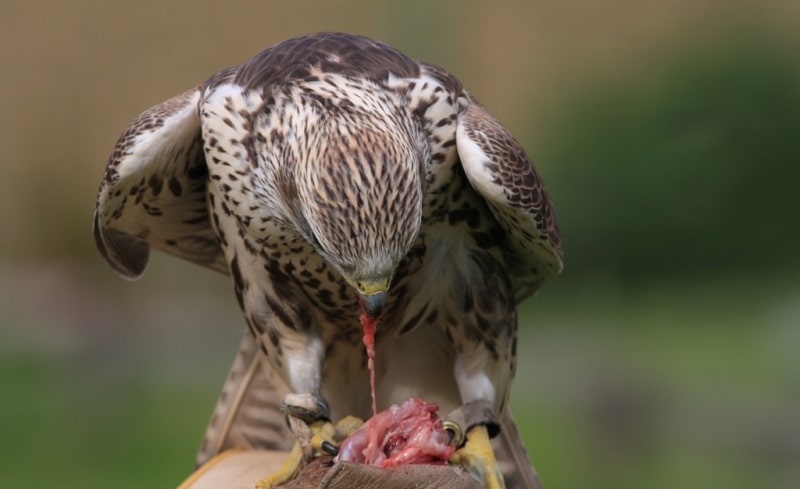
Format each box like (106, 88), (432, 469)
(0, 355), (217, 488)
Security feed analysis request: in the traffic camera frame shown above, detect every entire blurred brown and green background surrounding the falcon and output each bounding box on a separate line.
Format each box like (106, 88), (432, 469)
(0, 0), (800, 489)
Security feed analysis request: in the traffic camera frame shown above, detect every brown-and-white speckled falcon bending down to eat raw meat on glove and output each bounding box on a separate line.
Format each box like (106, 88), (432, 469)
(94, 33), (562, 487)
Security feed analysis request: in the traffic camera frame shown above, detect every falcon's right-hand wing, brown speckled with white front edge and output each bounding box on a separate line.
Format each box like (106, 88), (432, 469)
(456, 103), (563, 301)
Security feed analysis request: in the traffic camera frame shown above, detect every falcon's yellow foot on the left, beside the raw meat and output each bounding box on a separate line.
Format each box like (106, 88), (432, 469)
(256, 416), (364, 489)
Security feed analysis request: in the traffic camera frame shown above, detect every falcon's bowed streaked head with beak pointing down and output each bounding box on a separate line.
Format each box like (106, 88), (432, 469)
(293, 106), (429, 317)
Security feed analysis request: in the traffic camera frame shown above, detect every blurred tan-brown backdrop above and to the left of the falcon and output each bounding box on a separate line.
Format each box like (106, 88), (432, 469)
(0, 0), (800, 261)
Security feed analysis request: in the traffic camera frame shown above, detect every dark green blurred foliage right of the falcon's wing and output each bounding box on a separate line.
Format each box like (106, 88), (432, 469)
(543, 43), (800, 279)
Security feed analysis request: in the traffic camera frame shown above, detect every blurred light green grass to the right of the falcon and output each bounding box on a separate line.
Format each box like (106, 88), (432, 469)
(514, 277), (800, 488)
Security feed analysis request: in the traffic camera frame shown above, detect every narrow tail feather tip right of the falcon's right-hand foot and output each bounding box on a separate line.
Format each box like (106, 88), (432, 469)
(492, 409), (542, 489)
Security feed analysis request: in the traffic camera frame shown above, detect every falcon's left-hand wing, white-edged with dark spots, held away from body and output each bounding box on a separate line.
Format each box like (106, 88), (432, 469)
(93, 87), (227, 279)
